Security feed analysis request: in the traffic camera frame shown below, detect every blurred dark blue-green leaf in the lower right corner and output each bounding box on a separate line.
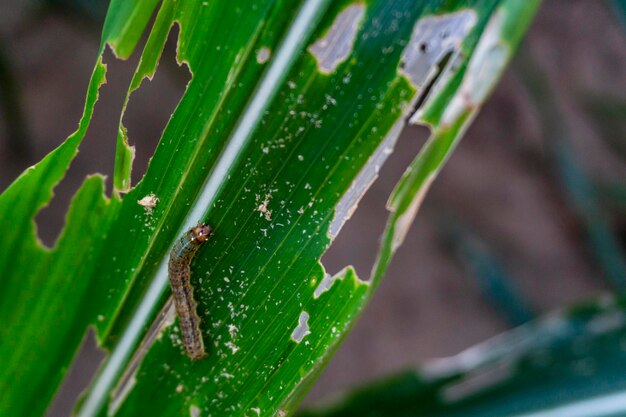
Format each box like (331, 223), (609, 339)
(299, 298), (626, 417)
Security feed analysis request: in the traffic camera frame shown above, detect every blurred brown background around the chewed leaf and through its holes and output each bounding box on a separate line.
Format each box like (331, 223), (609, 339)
(0, 0), (626, 416)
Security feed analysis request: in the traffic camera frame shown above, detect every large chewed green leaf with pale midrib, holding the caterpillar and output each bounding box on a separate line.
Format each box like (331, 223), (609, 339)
(0, 0), (538, 416)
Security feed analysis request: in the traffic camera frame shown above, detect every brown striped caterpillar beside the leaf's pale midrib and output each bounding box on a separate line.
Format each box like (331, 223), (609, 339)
(168, 224), (213, 361)
